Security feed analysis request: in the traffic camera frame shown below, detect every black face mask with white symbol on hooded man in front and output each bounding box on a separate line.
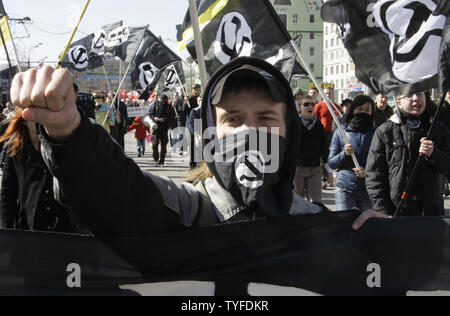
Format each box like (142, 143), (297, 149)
(208, 130), (292, 216)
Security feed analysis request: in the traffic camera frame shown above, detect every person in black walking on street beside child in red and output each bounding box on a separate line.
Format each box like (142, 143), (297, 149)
(150, 95), (175, 167)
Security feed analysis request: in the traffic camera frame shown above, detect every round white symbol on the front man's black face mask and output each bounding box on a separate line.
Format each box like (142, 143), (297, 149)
(235, 150), (266, 189)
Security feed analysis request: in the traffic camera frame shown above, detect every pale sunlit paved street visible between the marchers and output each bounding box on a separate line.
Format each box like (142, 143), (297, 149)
(0, 133), (450, 215)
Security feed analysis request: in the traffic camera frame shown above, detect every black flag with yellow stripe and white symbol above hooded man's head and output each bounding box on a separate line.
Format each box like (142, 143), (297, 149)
(178, 0), (296, 79)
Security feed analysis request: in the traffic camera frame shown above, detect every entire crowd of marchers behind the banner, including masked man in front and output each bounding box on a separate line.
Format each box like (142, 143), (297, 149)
(0, 58), (450, 235)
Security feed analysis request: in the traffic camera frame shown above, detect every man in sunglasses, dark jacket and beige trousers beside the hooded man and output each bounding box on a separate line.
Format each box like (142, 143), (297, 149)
(295, 96), (328, 203)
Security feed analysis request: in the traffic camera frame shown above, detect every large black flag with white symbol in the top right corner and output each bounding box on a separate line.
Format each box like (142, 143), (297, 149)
(322, 0), (450, 95)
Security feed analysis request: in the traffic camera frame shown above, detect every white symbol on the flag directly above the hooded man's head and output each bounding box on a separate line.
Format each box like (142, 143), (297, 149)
(213, 12), (253, 64)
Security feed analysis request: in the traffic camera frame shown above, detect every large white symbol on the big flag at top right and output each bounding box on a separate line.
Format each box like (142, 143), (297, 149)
(374, 0), (446, 83)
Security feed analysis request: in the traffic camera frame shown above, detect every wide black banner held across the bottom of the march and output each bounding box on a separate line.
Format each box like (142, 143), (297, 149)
(0, 211), (450, 296)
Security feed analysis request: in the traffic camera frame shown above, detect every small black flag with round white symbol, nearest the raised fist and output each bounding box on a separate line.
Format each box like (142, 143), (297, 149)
(62, 34), (103, 72)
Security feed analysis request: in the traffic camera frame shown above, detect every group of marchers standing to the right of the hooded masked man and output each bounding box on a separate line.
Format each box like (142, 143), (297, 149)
(294, 87), (450, 216)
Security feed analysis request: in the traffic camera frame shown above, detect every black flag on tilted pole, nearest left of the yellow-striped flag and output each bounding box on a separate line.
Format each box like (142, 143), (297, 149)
(131, 30), (181, 99)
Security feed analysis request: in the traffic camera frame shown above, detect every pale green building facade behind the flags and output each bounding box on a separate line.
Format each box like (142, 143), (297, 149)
(271, 0), (324, 91)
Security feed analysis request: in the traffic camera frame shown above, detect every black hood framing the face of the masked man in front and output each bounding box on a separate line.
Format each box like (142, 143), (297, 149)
(201, 57), (300, 216)
